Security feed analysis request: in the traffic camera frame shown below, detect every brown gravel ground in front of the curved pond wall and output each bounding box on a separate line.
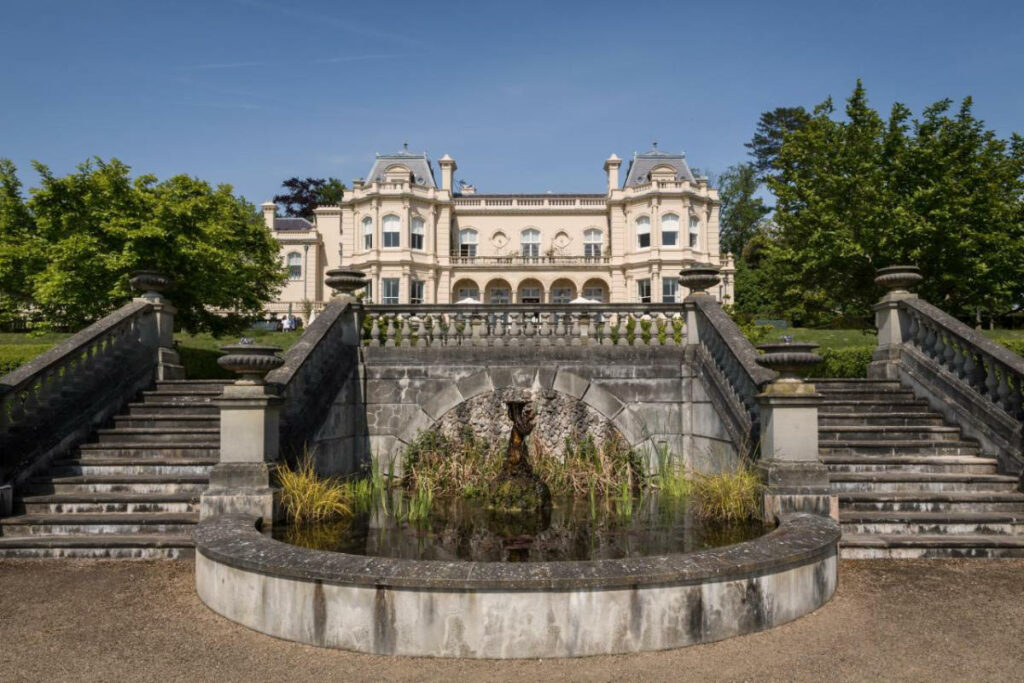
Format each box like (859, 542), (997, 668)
(0, 560), (1024, 683)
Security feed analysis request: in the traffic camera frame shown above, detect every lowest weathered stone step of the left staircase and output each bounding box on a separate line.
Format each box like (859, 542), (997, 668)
(0, 533), (196, 559)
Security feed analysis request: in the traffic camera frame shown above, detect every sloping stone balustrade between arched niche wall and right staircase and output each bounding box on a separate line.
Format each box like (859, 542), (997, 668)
(687, 295), (777, 450)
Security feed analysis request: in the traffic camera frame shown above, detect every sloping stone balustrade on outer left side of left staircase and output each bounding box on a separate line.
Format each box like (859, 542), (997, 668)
(0, 300), (159, 497)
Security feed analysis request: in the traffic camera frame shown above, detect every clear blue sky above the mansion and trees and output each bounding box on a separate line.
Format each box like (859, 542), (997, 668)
(0, 0), (1024, 203)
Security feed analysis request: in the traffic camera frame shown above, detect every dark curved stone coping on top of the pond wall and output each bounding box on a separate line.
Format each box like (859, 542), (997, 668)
(196, 514), (841, 591)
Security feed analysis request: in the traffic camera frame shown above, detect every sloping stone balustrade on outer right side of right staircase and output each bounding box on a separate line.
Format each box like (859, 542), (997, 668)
(899, 298), (1024, 420)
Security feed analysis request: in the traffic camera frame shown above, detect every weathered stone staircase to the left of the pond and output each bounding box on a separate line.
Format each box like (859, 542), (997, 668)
(0, 380), (226, 558)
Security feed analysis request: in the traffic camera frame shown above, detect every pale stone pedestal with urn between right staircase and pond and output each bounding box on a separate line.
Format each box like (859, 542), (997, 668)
(758, 342), (839, 519)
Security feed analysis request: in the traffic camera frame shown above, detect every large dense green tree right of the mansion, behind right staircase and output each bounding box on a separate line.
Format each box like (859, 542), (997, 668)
(761, 81), (1024, 324)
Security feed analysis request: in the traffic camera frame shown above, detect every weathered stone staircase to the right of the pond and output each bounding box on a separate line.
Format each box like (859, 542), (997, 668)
(811, 380), (1024, 558)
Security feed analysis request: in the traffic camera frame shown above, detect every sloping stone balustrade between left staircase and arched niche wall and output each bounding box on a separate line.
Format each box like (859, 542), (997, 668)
(266, 297), (359, 456)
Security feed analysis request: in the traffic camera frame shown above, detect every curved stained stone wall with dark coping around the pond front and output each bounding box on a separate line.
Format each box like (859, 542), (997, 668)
(196, 514), (840, 658)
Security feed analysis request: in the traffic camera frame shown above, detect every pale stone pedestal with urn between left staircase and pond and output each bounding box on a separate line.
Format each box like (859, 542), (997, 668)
(200, 340), (285, 526)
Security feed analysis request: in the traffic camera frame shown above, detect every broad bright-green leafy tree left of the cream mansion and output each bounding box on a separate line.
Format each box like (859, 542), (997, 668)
(0, 159), (285, 333)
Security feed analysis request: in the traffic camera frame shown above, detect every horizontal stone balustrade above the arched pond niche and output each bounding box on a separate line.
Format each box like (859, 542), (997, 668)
(362, 303), (685, 347)
